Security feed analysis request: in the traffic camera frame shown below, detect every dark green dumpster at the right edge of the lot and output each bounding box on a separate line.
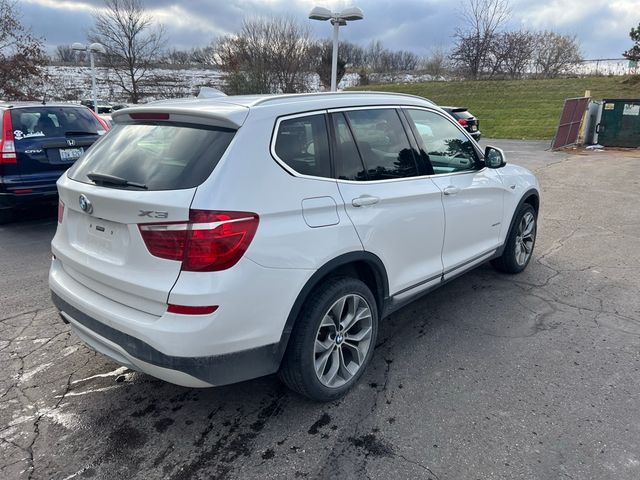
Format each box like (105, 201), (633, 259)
(596, 99), (640, 148)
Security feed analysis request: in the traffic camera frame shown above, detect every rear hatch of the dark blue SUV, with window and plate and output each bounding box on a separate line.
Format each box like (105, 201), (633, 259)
(11, 105), (106, 184)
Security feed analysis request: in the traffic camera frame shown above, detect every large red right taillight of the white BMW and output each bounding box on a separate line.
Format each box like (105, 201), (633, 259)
(138, 210), (259, 272)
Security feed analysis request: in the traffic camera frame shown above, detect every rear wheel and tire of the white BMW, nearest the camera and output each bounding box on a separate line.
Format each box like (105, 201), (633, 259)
(280, 277), (378, 402)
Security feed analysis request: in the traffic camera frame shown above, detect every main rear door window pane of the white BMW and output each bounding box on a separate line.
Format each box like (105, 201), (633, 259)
(345, 108), (420, 180)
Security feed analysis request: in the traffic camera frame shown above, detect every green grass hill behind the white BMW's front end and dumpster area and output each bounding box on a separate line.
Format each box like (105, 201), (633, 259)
(354, 77), (640, 140)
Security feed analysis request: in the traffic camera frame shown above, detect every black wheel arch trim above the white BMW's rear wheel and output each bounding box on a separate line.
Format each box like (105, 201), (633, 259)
(276, 251), (389, 363)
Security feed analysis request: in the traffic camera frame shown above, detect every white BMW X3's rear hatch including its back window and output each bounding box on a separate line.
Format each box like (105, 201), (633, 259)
(53, 115), (235, 315)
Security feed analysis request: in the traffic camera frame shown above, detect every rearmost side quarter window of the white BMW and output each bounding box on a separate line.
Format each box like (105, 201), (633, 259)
(274, 114), (331, 177)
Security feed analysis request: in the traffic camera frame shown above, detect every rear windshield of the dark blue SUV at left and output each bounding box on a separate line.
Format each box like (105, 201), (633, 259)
(11, 106), (105, 142)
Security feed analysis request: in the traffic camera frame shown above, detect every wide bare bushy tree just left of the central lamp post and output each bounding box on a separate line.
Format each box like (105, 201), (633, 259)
(214, 17), (312, 93)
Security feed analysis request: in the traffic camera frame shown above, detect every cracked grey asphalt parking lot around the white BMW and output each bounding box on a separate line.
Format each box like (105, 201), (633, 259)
(0, 141), (640, 480)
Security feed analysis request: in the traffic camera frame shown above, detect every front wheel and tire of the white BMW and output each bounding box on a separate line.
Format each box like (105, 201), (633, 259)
(491, 203), (538, 274)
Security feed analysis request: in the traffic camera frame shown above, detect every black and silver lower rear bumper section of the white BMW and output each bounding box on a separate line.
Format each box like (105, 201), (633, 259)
(51, 292), (278, 387)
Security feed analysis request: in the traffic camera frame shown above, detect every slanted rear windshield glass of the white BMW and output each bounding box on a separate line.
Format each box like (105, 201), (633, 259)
(69, 124), (235, 190)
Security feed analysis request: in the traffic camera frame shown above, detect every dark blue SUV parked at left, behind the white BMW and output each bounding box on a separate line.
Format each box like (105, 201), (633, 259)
(0, 104), (109, 223)
